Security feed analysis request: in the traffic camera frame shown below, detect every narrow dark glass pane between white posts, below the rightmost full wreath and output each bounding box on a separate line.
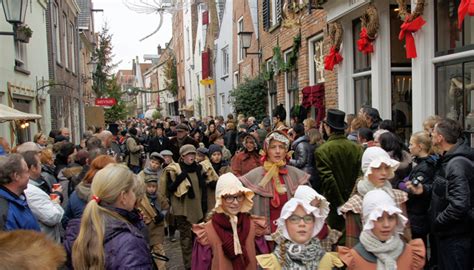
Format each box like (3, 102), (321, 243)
(392, 72), (413, 143)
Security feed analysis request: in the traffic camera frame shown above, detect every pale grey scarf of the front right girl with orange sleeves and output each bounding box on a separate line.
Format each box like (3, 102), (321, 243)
(359, 231), (404, 270)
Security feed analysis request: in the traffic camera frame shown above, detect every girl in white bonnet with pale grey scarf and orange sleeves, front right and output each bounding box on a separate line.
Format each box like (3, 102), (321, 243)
(338, 190), (426, 270)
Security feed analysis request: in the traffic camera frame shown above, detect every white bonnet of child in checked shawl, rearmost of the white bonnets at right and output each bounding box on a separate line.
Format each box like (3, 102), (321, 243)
(361, 146), (400, 178)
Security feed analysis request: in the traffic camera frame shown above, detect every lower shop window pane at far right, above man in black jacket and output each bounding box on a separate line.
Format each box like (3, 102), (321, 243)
(436, 58), (474, 132)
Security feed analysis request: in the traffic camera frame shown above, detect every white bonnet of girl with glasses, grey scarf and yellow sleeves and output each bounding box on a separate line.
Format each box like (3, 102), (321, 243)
(276, 197), (326, 241)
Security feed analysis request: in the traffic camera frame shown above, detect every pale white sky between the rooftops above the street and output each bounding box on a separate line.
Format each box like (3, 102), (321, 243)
(93, 0), (172, 69)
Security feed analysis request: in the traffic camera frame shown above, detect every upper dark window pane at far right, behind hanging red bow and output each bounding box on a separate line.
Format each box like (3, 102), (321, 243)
(435, 0), (474, 56)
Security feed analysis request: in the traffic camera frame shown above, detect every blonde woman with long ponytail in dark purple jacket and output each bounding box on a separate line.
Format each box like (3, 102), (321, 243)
(68, 164), (153, 270)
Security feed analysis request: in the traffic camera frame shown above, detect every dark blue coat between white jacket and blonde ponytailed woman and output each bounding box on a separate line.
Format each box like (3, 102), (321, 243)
(61, 182), (91, 228)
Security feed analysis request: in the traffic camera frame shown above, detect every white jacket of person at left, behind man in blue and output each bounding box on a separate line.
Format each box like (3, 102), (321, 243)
(25, 180), (64, 243)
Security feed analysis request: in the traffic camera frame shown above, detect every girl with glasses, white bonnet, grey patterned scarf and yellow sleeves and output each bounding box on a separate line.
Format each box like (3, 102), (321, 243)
(257, 198), (343, 270)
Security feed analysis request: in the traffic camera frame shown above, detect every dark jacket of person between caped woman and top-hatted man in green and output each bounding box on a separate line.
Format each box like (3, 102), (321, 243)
(289, 135), (315, 176)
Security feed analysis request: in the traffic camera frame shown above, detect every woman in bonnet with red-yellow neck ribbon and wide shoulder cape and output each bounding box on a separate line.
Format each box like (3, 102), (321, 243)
(240, 131), (310, 232)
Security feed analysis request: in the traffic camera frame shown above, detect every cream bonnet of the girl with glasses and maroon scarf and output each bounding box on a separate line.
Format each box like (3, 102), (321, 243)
(214, 173), (255, 213)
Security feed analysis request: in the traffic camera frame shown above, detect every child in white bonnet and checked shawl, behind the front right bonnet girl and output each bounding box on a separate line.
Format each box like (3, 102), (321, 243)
(339, 146), (411, 247)
